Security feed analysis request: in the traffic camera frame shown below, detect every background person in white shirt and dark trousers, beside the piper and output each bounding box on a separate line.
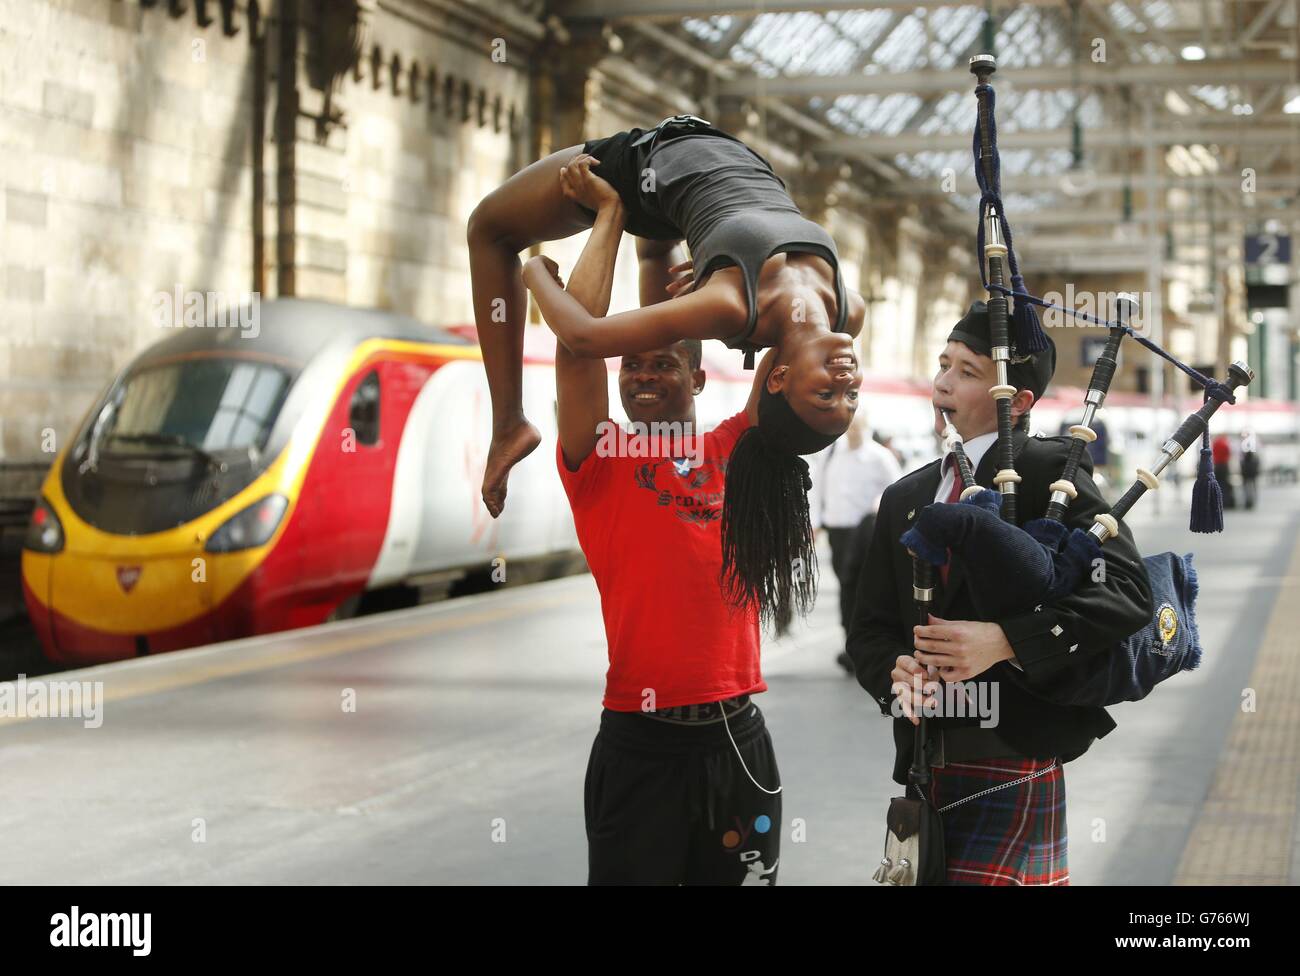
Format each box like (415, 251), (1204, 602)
(814, 409), (902, 674)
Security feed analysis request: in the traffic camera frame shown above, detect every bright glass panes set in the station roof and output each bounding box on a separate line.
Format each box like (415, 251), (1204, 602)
(681, 0), (1211, 205)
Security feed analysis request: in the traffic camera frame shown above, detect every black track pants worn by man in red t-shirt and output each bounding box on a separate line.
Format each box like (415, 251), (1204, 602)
(584, 703), (781, 885)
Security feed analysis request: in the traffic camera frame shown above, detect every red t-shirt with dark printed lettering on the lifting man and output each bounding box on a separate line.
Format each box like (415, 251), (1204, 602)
(555, 412), (767, 712)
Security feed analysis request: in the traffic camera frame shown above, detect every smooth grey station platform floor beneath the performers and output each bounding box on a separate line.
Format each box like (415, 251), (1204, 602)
(0, 486), (1300, 885)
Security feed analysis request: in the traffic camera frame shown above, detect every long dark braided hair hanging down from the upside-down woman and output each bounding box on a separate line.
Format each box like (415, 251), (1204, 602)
(720, 387), (835, 636)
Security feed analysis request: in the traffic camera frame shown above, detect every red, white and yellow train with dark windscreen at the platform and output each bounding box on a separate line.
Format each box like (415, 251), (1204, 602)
(22, 298), (1297, 665)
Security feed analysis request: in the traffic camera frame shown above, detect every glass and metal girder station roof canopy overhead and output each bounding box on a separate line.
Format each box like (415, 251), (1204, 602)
(556, 0), (1300, 267)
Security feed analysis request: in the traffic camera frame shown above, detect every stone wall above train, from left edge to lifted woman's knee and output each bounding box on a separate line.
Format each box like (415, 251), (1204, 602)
(0, 0), (541, 460)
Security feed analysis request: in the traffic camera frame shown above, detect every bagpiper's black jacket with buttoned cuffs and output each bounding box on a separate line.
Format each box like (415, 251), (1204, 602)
(848, 430), (1152, 784)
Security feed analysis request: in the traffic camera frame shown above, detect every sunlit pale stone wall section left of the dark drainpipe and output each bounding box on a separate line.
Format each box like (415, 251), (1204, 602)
(0, 0), (265, 459)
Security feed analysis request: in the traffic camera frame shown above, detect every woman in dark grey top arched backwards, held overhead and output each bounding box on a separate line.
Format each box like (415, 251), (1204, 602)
(468, 116), (865, 632)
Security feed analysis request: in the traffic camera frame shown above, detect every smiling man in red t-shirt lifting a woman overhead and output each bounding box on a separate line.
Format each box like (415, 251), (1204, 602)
(540, 152), (781, 884)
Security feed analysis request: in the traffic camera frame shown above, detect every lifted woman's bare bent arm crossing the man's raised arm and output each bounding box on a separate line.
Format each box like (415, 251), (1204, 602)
(524, 257), (748, 359)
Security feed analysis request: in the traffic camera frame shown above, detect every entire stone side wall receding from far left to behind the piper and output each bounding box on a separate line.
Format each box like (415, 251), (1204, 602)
(0, 0), (969, 473)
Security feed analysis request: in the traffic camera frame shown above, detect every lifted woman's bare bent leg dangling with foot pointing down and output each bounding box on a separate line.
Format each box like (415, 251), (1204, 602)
(467, 146), (592, 519)
